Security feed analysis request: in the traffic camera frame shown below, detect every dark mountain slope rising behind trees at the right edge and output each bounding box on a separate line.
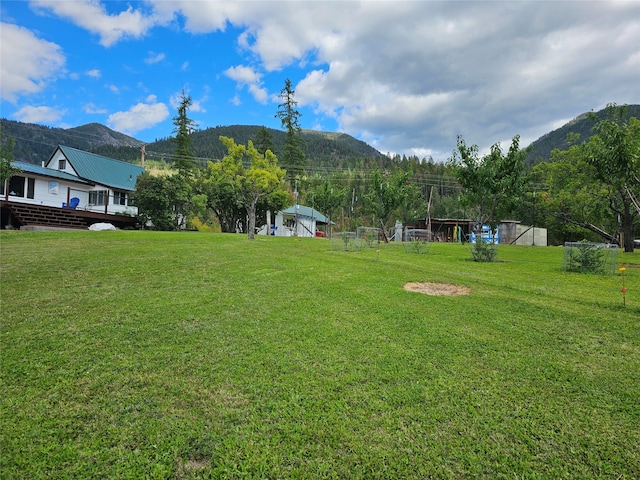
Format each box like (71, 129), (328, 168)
(526, 105), (640, 165)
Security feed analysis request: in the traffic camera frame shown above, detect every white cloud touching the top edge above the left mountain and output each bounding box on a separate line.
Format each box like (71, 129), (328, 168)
(31, 0), (155, 47)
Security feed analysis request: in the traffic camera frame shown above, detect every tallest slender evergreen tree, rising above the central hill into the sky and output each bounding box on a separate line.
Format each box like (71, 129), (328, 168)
(276, 78), (306, 170)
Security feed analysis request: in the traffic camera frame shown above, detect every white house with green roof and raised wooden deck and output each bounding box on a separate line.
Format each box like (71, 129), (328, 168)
(0, 146), (144, 228)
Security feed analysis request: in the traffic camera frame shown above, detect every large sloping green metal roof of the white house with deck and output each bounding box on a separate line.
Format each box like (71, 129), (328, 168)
(52, 145), (144, 191)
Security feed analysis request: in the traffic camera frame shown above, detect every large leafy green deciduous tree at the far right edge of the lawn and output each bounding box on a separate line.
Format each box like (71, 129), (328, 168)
(533, 104), (640, 252)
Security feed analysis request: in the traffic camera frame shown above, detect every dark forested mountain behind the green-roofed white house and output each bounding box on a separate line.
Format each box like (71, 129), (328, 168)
(0, 118), (142, 164)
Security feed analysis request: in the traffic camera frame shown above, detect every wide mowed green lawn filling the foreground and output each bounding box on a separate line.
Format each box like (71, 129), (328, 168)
(0, 231), (640, 479)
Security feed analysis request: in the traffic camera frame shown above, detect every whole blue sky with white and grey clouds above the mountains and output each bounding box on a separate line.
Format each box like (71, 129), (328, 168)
(0, 0), (640, 161)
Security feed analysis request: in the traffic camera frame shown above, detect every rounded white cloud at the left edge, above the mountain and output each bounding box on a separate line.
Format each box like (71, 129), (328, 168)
(0, 23), (65, 102)
